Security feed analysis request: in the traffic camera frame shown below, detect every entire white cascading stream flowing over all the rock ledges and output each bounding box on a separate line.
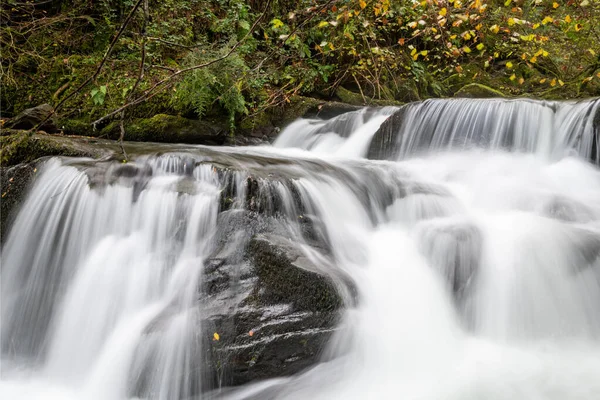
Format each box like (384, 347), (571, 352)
(0, 100), (600, 400)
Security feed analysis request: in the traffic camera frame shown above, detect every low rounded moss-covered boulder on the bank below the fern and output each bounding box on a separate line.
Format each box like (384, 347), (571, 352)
(99, 114), (227, 145)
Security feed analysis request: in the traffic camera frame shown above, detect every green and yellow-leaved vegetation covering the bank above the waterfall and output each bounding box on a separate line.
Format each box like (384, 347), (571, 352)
(0, 0), (600, 131)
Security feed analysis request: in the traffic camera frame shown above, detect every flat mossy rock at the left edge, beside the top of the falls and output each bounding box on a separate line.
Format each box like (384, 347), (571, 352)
(0, 131), (108, 167)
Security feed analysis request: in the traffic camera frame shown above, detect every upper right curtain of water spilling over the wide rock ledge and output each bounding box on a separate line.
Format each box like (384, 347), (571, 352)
(369, 99), (600, 163)
